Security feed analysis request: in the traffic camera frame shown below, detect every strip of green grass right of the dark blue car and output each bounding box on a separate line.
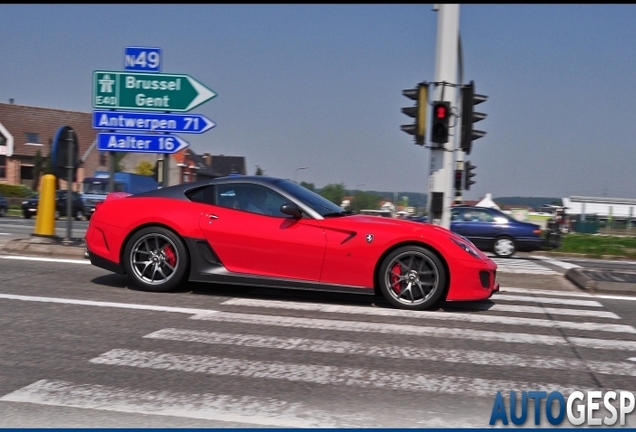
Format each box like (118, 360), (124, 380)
(554, 233), (636, 259)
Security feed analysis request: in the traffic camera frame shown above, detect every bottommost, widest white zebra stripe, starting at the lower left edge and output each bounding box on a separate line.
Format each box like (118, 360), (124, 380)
(0, 380), (355, 428)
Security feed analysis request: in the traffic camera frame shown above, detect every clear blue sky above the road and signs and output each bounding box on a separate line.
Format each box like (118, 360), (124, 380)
(0, 4), (636, 199)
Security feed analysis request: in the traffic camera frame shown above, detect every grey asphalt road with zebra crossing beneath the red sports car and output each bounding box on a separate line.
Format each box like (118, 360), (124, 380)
(0, 251), (636, 428)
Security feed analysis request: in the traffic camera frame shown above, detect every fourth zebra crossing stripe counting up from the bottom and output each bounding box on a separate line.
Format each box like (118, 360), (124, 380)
(190, 312), (636, 351)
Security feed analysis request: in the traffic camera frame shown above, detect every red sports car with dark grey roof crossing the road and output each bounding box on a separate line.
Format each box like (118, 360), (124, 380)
(86, 176), (499, 310)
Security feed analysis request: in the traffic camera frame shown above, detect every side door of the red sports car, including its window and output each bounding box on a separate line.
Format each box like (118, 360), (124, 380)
(199, 182), (327, 281)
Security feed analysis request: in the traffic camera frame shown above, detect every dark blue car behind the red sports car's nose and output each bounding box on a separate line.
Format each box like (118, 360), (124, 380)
(451, 206), (544, 257)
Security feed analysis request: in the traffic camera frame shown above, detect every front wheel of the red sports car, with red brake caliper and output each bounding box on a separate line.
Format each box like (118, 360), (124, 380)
(378, 246), (448, 310)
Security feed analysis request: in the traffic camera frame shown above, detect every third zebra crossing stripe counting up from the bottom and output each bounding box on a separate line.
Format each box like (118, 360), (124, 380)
(144, 328), (636, 376)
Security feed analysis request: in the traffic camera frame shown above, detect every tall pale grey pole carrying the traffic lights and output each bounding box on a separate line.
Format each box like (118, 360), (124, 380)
(427, 3), (460, 229)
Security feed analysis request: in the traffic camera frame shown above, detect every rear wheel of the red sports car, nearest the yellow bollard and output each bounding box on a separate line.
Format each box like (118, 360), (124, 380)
(122, 227), (189, 292)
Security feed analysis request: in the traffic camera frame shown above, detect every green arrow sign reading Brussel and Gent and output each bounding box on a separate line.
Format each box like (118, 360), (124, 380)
(93, 71), (216, 112)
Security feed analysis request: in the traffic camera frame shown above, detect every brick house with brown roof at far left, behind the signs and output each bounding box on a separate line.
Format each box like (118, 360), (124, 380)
(0, 99), (99, 190)
